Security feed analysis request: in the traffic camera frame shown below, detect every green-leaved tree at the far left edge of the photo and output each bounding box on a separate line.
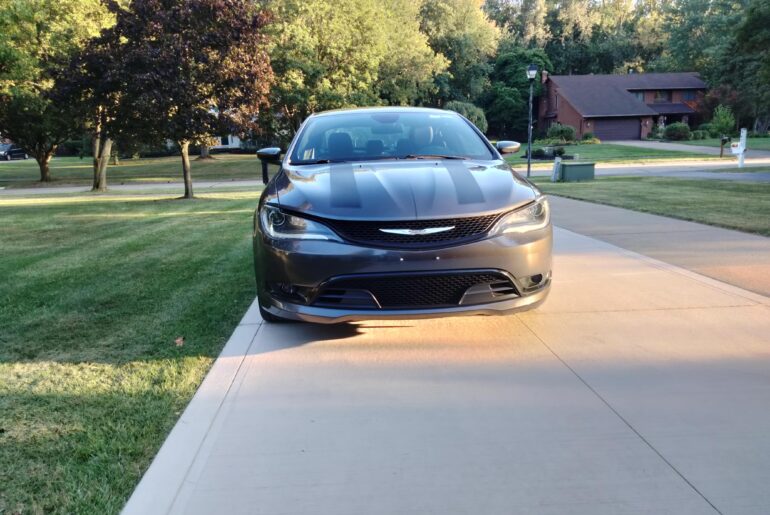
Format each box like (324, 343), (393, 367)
(0, 0), (112, 181)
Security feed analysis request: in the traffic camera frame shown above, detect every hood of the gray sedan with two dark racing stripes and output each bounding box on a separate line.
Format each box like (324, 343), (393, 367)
(275, 159), (539, 220)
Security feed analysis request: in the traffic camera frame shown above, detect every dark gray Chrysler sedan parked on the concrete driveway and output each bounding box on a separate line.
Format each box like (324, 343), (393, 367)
(253, 107), (552, 323)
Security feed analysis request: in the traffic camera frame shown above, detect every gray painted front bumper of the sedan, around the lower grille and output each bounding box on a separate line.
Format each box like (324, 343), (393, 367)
(254, 225), (552, 323)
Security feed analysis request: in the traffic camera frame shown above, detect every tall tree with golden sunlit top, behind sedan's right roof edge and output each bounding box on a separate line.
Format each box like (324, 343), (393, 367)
(420, 0), (500, 105)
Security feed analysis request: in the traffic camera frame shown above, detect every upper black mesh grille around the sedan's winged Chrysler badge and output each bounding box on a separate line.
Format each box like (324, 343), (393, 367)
(324, 213), (502, 248)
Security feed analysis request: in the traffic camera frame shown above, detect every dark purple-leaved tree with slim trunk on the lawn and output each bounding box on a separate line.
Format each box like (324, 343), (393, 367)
(97, 0), (273, 198)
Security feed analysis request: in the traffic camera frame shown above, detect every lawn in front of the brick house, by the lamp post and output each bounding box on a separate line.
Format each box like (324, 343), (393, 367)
(507, 143), (719, 169)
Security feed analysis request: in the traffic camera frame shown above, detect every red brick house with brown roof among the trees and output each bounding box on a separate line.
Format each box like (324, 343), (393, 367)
(538, 72), (706, 140)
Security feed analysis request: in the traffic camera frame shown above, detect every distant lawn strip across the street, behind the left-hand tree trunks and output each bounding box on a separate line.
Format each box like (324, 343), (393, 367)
(0, 154), (262, 188)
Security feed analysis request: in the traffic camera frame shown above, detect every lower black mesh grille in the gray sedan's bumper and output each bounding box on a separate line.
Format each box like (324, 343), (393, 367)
(313, 271), (517, 309)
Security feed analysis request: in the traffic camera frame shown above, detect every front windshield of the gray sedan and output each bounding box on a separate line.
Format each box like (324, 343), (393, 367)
(290, 111), (495, 165)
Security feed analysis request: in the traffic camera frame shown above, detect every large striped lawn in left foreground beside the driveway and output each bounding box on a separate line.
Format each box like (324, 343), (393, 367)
(0, 190), (258, 514)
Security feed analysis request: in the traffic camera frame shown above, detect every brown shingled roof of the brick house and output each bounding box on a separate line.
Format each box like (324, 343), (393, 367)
(548, 72), (706, 118)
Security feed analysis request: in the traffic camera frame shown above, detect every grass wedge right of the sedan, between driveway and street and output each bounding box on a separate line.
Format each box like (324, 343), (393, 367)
(535, 177), (770, 236)
